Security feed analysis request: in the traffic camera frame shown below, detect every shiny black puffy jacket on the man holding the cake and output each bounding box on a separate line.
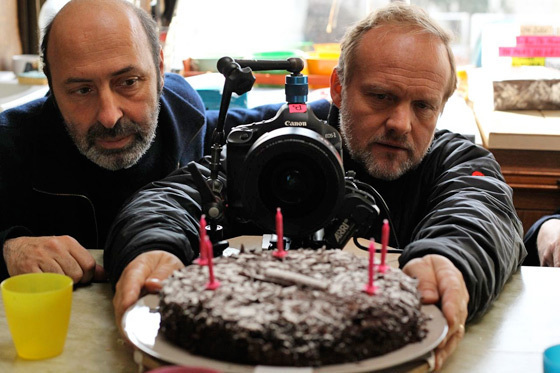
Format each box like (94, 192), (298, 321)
(105, 104), (526, 320)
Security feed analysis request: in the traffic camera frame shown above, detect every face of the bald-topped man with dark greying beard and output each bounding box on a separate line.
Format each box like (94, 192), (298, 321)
(48, 4), (161, 170)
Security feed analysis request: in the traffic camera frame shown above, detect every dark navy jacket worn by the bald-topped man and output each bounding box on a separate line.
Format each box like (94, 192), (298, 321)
(0, 74), (288, 279)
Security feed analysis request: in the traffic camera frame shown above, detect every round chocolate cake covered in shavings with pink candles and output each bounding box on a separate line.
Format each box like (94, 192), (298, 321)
(160, 249), (427, 366)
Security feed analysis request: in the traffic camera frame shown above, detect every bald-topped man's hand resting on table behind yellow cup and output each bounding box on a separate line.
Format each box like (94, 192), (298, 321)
(3, 236), (105, 283)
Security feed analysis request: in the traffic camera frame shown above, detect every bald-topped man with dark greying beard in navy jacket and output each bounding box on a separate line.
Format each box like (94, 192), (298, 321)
(0, 0), (288, 283)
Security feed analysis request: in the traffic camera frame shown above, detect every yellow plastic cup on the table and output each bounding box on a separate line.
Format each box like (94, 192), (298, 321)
(0, 273), (73, 360)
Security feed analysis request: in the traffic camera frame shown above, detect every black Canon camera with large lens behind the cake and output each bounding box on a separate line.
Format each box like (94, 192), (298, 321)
(226, 103), (345, 237)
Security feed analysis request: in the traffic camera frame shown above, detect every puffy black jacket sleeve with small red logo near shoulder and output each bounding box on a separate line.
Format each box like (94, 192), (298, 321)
(399, 133), (526, 320)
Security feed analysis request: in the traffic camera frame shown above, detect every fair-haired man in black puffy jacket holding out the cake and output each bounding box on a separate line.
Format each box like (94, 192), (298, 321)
(105, 3), (526, 369)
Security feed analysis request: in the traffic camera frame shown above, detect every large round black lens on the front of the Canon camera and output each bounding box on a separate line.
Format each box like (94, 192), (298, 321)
(240, 127), (344, 237)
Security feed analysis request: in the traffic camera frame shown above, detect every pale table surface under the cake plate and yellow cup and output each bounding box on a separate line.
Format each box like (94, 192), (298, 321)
(0, 238), (560, 373)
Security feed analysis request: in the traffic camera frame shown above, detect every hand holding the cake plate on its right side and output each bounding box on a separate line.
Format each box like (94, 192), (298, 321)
(403, 255), (469, 370)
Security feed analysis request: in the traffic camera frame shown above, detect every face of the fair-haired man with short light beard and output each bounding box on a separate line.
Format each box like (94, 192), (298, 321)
(331, 26), (451, 180)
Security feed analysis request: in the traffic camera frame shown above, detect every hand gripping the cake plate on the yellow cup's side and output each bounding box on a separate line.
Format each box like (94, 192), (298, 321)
(113, 251), (185, 332)
